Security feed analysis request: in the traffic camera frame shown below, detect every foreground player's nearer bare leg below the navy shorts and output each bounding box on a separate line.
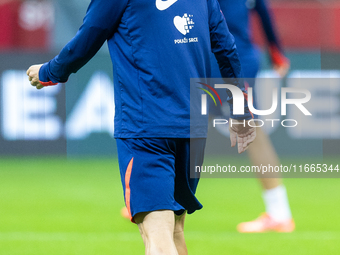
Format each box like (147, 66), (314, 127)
(134, 210), (178, 255)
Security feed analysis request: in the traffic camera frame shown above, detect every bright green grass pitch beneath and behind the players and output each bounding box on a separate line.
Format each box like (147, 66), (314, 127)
(0, 158), (340, 255)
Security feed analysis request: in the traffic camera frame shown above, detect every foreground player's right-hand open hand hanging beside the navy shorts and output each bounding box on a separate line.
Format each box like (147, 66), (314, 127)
(229, 119), (256, 153)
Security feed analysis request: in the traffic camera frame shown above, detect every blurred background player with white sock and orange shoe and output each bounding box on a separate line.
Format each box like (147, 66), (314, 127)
(211, 0), (295, 232)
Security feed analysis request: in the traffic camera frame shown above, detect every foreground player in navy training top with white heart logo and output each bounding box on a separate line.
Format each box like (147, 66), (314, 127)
(27, 0), (256, 254)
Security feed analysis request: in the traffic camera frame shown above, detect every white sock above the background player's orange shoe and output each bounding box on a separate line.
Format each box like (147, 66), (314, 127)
(262, 185), (292, 221)
